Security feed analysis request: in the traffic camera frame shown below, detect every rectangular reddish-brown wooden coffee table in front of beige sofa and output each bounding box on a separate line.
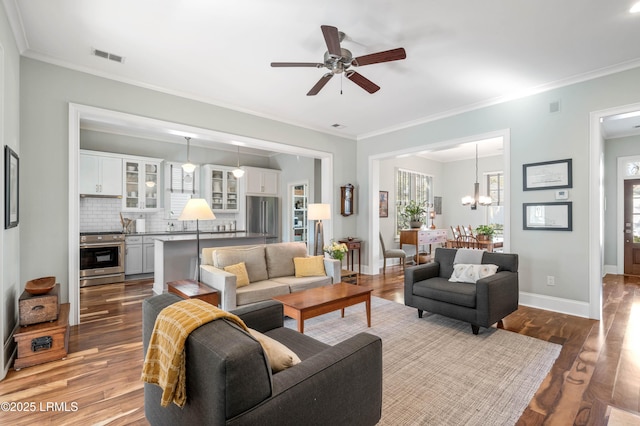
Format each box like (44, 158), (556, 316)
(273, 283), (373, 333)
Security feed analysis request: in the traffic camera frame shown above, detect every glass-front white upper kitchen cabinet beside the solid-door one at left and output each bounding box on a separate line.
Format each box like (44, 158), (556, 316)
(122, 158), (162, 211)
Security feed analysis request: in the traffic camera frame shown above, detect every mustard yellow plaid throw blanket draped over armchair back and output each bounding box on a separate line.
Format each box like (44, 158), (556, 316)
(142, 299), (248, 407)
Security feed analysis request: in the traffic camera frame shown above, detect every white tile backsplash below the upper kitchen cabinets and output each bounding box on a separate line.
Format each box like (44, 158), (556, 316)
(80, 198), (237, 232)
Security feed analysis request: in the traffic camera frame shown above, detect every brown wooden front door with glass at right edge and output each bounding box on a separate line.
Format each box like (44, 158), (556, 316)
(623, 179), (640, 275)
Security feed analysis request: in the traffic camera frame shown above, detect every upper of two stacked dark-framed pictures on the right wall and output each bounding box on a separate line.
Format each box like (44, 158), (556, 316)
(522, 158), (573, 191)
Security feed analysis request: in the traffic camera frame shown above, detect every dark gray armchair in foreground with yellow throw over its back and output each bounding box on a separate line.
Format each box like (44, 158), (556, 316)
(142, 294), (382, 425)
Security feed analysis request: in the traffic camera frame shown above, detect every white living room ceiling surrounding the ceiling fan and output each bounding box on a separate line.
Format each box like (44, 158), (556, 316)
(3, 0), (640, 146)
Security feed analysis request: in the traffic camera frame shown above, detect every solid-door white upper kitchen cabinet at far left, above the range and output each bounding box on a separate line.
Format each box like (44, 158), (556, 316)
(79, 151), (122, 197)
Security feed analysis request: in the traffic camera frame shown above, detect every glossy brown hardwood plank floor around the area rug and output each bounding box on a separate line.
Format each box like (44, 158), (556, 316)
(0, 272), (640, 425)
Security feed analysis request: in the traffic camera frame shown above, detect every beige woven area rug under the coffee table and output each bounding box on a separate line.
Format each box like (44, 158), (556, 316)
(285, 297), (561, 426)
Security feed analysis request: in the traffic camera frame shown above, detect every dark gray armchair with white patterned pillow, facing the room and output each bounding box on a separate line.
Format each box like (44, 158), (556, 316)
(404, 248), (519, 334)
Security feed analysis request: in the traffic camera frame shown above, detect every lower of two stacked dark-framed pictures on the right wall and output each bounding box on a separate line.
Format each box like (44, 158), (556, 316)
(522, 201), (573, 231)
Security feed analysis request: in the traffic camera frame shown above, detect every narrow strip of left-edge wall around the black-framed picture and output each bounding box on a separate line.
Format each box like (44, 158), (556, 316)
(0, 3), (25, 379)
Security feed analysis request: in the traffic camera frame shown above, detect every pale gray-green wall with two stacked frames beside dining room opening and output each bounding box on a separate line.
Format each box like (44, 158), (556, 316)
(357, 65), (640, 313)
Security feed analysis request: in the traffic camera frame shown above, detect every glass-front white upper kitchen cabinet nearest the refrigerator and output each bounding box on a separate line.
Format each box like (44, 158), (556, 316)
(202, 164), (240, 213)
